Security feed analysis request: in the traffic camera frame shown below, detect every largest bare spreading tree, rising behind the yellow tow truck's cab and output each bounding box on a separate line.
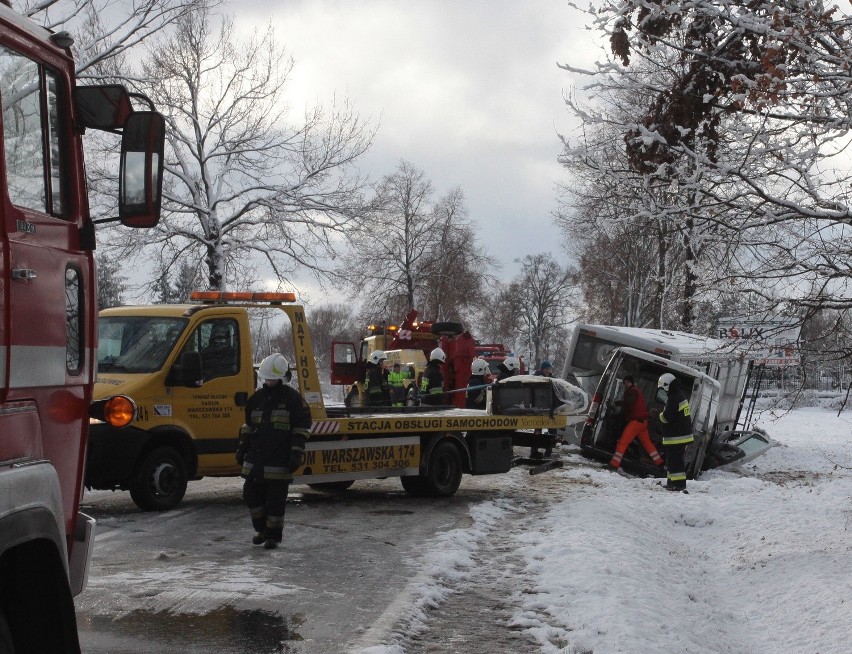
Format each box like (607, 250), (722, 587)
(109, 5), (372, 289)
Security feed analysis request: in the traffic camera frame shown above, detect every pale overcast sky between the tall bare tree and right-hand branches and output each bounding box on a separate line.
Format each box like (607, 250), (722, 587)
(227, 0), (596, 299)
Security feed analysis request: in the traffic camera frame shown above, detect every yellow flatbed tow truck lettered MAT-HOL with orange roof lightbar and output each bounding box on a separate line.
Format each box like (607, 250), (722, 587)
(86, 291), (584, 511)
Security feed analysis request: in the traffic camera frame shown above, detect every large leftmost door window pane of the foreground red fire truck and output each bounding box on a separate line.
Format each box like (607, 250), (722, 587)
(0, 47), (47, 211)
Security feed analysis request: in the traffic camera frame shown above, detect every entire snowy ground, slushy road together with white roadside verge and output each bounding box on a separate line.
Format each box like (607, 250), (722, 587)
(77, 408), (852, 654)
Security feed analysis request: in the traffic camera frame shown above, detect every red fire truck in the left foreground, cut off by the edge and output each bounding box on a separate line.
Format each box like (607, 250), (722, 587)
(0, 0), (165, 654)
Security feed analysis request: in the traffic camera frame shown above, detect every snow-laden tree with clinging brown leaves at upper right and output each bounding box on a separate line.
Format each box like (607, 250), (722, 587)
(564, 0), (852, 338)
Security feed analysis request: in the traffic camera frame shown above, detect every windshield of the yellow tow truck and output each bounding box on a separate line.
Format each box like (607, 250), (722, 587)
(98, 316), (187, 373)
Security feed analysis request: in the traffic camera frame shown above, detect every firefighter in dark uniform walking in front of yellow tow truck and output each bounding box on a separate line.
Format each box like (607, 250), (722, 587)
(237, 354), (311, 550)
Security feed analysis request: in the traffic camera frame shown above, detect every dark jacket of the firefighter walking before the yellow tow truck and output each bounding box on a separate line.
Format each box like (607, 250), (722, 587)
(237, 383), (311, 482)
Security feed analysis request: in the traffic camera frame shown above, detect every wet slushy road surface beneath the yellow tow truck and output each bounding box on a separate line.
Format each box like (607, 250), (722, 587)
(77, 469), (560, 654)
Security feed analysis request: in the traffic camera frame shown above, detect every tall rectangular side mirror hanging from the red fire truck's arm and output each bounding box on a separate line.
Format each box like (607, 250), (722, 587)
(118, 111), (166, 232)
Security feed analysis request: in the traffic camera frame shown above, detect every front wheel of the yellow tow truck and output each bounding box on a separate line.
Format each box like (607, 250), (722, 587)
(130, 445), (187, 511)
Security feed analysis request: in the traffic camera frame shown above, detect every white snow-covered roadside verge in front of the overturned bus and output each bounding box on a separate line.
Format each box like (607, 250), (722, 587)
(357, 408), (852, 654)
